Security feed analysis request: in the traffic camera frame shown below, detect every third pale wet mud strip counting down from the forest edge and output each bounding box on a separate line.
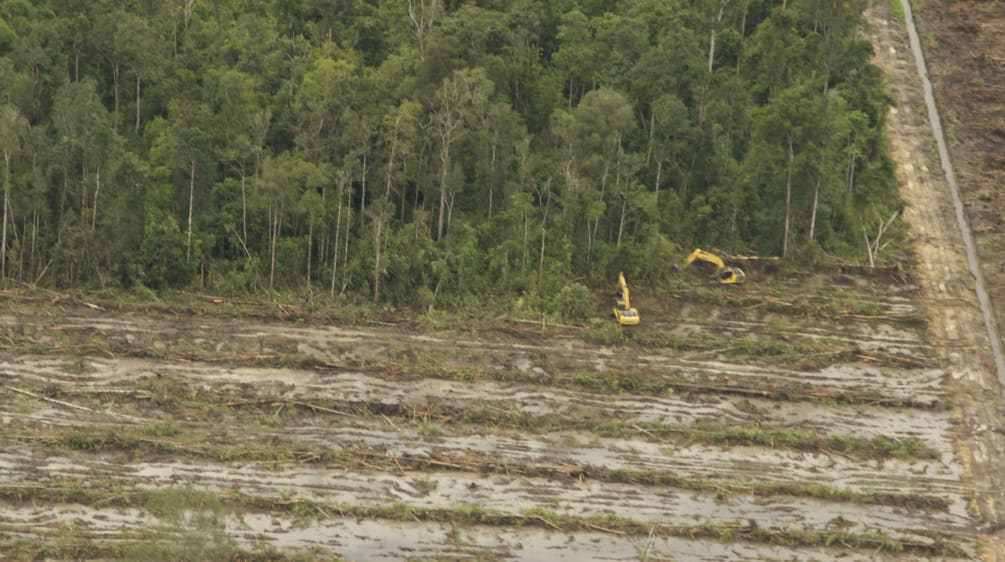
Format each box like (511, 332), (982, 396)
(0, 406), (966, 502)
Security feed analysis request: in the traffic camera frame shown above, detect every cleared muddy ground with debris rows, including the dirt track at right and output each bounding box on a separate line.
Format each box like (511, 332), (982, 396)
(0, 4), (1005, 561)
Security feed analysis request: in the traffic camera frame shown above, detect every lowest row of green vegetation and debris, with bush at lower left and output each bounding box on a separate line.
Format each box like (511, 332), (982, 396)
(0, 483), (966, 562)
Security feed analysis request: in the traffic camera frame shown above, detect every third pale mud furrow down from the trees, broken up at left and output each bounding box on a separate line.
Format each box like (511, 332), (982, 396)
(5, 396), (965, 513)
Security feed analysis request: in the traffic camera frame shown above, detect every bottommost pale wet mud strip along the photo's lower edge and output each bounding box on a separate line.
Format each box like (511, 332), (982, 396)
(0, 504), (935, 562)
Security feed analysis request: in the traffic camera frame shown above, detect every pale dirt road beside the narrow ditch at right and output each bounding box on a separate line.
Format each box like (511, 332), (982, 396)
(873, 3), (1005, 560)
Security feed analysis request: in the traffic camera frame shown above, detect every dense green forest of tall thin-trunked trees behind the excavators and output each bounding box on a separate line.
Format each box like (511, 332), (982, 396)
(0, 0), (898, 310)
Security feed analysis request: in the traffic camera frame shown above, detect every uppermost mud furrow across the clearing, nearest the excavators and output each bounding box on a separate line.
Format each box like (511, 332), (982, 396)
(0, 311), (945, 405)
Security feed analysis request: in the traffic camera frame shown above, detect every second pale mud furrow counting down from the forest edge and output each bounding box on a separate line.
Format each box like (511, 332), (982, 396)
(0, 356), (952, 454)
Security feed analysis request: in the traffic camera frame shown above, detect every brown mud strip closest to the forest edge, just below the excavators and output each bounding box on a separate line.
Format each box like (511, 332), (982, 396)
(1, 309), (946, 407)
